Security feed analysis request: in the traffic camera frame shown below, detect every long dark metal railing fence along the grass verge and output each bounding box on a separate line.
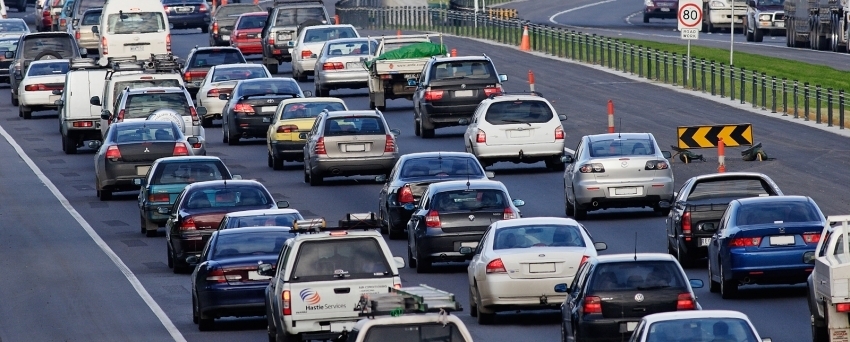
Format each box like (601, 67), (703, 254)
(336, 0), (846, 129)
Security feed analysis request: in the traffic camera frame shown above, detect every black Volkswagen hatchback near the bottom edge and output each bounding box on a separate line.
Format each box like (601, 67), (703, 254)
(555, 253), (703, 342)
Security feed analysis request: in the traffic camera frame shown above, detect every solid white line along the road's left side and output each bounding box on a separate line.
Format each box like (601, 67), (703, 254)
(0, 126), (186, 342)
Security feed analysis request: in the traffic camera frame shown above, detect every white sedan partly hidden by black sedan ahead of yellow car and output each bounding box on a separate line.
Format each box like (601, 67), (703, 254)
(197, 64), (272, 127)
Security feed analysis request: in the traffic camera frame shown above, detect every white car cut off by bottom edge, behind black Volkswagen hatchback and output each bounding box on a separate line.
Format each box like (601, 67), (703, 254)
(629, 310), (770, 342)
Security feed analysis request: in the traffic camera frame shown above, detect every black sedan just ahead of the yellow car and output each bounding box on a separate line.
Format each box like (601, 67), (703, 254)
(219, 77), (313, 145)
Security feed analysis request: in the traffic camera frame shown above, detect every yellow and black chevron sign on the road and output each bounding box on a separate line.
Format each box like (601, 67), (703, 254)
(677, 124), (753, 148)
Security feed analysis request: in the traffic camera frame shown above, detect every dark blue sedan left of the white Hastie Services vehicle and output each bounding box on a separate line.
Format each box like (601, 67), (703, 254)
(190, 227), (292, 331)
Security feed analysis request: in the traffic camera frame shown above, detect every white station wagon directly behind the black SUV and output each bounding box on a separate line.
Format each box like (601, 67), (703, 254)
(463, 93), (567, 171)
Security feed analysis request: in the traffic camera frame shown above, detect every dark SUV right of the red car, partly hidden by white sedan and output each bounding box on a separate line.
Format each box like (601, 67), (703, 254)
(262, 0), (331, 74)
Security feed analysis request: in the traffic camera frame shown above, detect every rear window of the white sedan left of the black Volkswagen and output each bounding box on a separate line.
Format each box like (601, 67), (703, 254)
(493, 224), (585, 250)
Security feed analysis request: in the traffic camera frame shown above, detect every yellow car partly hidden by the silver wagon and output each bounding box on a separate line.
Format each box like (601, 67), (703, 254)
(266, 97), (348, 170)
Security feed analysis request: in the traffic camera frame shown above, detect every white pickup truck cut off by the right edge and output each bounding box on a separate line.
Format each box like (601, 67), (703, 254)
(803, 215), (850, 342)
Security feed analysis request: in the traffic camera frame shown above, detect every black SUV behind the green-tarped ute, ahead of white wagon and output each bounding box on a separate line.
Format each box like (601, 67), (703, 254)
(411, 55), (508, 138)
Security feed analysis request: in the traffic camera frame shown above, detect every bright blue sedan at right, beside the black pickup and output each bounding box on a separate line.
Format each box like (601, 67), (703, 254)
(708, 196), (826, 299)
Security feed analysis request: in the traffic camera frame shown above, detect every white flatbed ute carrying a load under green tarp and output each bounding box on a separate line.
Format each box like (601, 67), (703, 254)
(364, 34), (446, 110)
